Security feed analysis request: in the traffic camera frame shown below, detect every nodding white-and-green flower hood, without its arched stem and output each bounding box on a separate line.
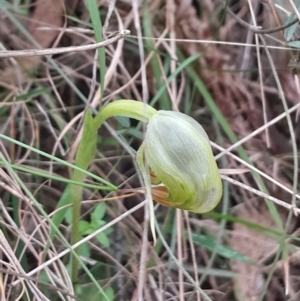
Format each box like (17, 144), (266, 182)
(137, 110), (222, 213)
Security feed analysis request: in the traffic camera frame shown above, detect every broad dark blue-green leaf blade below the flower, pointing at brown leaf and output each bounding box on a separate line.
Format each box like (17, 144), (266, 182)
(186, 233), (253, 263)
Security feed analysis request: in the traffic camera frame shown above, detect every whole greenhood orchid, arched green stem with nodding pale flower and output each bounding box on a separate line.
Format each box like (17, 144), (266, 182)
(69, 99), (222, 276)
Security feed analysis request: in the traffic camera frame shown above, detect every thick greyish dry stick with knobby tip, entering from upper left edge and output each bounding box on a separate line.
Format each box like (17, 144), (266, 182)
(0, 29), (130, 58)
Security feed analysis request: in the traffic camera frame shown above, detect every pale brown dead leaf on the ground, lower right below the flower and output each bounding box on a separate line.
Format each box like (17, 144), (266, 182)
(229, 203), (278, 301)
